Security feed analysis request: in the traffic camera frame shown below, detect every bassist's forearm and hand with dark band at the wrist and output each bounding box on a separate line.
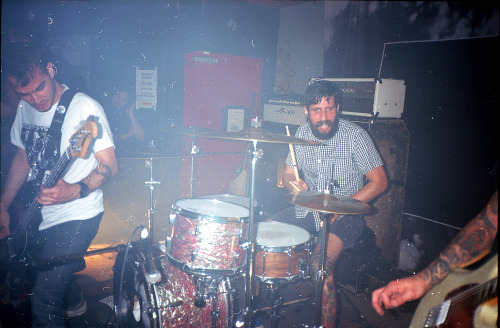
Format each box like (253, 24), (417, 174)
(36, 147), (118, 205)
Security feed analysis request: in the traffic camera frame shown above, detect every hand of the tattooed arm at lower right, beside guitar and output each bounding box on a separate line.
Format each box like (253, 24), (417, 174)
(372, 274), (430, 315)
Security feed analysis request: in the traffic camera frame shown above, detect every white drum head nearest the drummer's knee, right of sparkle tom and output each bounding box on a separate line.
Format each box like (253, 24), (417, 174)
(257, 221), (311, 247)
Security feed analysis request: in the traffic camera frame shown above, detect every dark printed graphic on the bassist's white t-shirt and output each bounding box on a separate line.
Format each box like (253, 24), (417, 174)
(21, 124), (58, 183)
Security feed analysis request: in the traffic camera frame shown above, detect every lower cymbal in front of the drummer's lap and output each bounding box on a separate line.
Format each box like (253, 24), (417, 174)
(284, 191), (371, 214)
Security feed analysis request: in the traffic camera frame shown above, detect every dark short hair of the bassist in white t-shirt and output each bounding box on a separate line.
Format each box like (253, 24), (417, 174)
(2, 42), (49, 87)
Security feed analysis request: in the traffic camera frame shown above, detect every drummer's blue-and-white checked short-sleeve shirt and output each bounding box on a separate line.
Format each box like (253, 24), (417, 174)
(286, 119), (383, 230)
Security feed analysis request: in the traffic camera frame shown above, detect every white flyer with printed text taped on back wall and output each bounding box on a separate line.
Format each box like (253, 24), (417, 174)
(135, 67), (158, 110)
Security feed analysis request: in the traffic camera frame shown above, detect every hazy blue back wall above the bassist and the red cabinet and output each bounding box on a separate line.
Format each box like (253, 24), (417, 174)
(2, 0), (279, 124)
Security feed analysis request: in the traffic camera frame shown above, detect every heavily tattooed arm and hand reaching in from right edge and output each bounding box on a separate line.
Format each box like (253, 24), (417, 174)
(372, 190), (498, 315)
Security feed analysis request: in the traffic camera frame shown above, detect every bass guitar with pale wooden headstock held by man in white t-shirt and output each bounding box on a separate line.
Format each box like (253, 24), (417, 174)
(7, 115), (98, 261)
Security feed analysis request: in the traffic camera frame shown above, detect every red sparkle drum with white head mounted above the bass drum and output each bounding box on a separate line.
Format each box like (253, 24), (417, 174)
(167, 198), (249, 274)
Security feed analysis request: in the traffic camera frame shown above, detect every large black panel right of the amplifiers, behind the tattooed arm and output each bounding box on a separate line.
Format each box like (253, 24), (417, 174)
(381, 37), (500, 227)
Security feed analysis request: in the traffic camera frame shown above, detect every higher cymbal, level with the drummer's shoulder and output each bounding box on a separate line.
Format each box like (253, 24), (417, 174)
(189, 127), (320, 145)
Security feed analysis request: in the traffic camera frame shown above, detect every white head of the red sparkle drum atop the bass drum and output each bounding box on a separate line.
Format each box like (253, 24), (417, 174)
(175, 198), (249, 218)
